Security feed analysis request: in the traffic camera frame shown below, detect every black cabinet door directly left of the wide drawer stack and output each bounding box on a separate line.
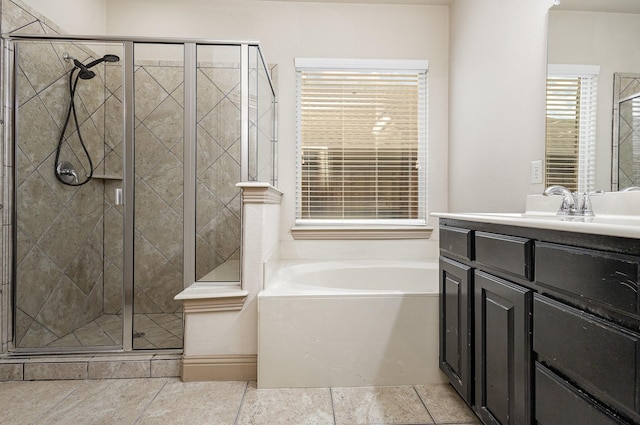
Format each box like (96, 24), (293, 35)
(474, 270), (532, 425)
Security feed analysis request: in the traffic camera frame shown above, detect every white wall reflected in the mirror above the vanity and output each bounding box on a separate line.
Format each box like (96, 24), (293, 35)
(549, 10), (640, 191)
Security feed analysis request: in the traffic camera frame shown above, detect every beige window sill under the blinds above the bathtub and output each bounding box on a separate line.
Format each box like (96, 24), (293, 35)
(291, 226), (433, 240)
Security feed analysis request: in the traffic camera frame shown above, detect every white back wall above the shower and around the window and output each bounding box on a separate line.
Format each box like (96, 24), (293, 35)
(107, 0), (449, 252)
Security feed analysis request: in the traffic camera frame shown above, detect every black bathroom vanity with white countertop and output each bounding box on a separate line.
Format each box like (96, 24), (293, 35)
(437, 202), (640, 425)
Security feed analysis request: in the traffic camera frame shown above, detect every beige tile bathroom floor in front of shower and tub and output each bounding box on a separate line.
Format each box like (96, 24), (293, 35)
(0, 378), (480, 425)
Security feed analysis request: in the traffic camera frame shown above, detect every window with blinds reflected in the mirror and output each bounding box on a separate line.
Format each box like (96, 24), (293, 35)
(545, 65), (599, 192)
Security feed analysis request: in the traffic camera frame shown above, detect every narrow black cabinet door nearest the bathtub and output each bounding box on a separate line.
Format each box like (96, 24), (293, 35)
(440, 257), (473, 404)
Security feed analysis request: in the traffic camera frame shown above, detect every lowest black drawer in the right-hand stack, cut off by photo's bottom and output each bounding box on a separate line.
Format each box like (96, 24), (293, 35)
(535, 363), (628, 425)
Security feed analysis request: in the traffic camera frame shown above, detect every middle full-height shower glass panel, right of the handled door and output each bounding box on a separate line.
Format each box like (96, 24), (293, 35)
(133, 43), (184, 350)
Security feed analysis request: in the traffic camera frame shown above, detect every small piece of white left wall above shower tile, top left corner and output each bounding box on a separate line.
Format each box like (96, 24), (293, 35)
(23, 0), (107, 35)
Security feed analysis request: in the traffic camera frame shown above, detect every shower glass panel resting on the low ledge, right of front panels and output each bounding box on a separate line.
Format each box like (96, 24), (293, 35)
(194, 44), (242, 283)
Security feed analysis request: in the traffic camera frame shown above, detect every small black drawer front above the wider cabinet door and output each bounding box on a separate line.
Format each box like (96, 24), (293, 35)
(475, 232), (533, 280)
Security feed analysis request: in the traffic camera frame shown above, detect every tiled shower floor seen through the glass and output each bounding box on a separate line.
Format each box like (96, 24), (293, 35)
(47, 313), (183, 349)
